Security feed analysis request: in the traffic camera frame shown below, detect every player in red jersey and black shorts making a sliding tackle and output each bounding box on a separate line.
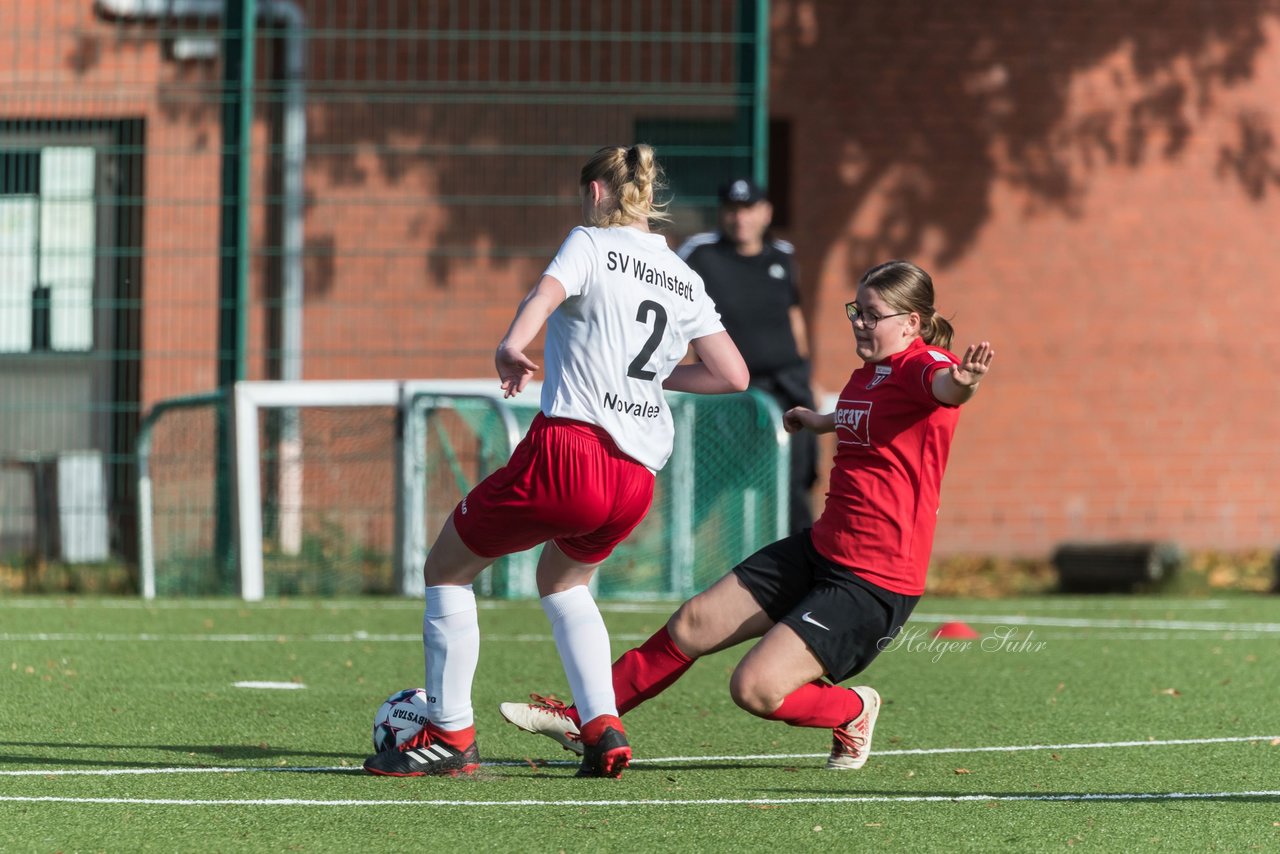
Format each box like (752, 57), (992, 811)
(502, 261), (995, 769)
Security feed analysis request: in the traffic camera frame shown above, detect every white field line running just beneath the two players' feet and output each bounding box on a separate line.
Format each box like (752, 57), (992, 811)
(0, 735), (1280, 777)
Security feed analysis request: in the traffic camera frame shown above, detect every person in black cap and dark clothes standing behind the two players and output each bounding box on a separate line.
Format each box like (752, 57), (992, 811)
(677, 178), (818, 534)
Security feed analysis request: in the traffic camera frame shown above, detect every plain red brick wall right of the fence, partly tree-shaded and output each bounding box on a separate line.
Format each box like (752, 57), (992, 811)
(772, 0), (1280, 556)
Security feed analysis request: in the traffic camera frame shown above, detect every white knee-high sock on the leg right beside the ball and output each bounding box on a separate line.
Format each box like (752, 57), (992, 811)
(422, 584), (480, 730)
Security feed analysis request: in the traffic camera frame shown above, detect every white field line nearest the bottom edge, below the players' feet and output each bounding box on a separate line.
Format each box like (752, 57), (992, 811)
(0, 790), (1280, 808)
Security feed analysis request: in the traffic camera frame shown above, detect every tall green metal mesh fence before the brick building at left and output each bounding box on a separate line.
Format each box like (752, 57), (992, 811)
(0, 0), (767, 594)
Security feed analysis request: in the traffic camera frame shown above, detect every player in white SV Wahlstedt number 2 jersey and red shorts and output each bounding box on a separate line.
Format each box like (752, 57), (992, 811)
(365, 145), (749, 777)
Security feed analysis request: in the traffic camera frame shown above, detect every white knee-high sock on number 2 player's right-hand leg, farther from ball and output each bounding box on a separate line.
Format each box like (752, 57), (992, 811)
(543, 586), (618, 723)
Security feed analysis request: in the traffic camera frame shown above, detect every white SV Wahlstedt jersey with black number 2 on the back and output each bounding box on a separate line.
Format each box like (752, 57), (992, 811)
(543, 227), (724, 471)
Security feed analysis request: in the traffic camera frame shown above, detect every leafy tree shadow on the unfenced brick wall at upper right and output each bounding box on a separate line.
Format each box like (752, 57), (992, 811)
(772, 0), (1280, 270)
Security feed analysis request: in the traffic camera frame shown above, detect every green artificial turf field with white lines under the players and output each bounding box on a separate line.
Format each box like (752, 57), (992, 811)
(0, 595), (1280, 853)
